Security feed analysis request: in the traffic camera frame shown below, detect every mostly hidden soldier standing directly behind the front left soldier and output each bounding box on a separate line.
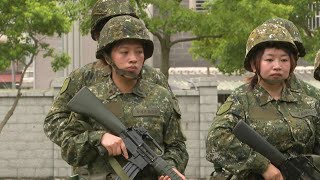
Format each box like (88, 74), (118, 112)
(43, 0), (180, 156)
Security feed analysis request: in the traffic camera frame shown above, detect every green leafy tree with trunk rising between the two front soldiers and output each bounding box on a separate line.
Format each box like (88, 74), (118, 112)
(69, 0), (320, 75)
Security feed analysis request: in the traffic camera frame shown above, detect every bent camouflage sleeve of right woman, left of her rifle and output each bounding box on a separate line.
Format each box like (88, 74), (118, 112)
(206, 95), (269, 177)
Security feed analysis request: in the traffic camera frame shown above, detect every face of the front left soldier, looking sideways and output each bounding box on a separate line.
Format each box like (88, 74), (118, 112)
(111, 40), (144, 75)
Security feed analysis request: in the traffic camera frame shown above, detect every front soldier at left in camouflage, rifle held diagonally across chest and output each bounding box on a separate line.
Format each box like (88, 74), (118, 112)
(61, 15), (188, 180)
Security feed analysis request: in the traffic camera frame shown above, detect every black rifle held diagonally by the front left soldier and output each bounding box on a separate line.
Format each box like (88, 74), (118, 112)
(67, 87), (181, 180)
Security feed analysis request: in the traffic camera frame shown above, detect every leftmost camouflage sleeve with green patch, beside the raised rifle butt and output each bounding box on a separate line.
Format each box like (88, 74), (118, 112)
(43, 70), (84, 146)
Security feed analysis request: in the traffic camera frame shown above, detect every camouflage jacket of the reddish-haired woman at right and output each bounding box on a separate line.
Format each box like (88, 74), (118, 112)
(206, 84), (320, 179)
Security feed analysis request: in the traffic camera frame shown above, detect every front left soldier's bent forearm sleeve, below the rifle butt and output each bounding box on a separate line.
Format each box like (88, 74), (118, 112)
(61, 113), (106, 166)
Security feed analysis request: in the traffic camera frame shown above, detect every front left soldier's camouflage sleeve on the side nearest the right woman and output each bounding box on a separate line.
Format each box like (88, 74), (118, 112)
(163, 100), (189, 173)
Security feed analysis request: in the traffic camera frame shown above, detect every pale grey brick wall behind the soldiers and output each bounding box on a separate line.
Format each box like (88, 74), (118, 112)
(0, 78), (217, 179)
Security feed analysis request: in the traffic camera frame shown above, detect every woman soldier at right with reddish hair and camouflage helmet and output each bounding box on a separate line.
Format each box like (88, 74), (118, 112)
(206, 23), (320, 179)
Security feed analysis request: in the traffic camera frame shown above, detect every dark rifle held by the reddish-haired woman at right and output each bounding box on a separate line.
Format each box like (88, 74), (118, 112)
(233, 121), (320, 180)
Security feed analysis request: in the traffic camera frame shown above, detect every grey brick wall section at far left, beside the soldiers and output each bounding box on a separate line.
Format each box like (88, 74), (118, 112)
(0, 91), (58, 178)
